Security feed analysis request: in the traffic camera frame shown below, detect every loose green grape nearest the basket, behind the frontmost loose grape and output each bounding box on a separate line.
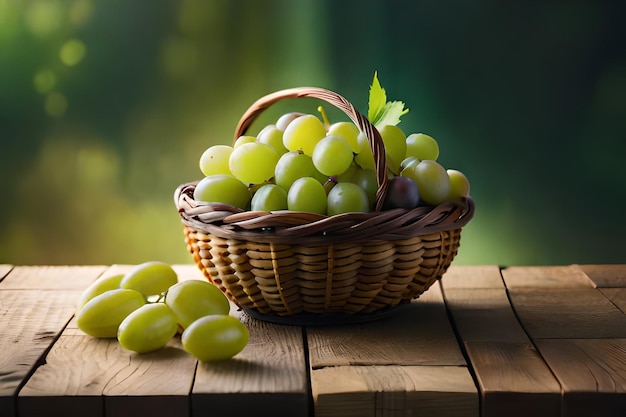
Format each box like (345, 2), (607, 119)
(165, 279), (230, 329)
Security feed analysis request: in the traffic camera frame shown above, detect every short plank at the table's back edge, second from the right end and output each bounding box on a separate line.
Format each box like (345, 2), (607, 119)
(502, 265), (595, 289)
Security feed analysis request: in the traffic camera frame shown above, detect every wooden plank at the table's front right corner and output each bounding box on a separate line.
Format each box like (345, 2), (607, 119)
(536, 339), (626, 417)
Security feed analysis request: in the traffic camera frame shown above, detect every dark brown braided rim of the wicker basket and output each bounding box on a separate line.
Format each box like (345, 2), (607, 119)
(174, 182), (474, 245)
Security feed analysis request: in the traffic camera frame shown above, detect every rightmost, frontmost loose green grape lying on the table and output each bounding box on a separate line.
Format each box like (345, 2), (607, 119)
(181, 315), (250, 362)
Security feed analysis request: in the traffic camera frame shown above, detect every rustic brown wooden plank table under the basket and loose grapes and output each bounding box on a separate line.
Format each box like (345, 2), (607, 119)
(0, 265), (626, 417)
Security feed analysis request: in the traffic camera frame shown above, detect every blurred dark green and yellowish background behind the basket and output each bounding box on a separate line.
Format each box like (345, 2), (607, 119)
(0, 0), (626, 265)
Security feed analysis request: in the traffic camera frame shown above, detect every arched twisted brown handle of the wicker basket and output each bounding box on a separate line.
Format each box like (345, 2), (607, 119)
(233, 87), (389, 211)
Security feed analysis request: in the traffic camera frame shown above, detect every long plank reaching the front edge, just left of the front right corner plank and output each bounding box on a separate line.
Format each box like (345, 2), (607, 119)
(443, 282), (560, 417)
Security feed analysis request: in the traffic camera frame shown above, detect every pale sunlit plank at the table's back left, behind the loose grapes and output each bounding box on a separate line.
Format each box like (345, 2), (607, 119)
(0, 266), (107, 291)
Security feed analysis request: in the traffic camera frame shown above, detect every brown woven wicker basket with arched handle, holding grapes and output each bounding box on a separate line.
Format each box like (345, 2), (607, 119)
(174, 87), (474, 324)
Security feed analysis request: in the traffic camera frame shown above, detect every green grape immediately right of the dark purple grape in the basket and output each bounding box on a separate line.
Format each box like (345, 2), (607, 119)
(402, 159), (450, 205)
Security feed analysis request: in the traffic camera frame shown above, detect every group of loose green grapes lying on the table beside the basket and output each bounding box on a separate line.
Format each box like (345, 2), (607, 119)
(76, 261), (249, 362)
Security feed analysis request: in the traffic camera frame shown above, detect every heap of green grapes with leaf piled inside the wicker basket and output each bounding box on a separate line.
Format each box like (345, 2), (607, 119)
(193, 75), (470, 216)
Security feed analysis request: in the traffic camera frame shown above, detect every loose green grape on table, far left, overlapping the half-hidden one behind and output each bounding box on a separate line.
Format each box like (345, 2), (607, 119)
(76, 288), (146, 338)
